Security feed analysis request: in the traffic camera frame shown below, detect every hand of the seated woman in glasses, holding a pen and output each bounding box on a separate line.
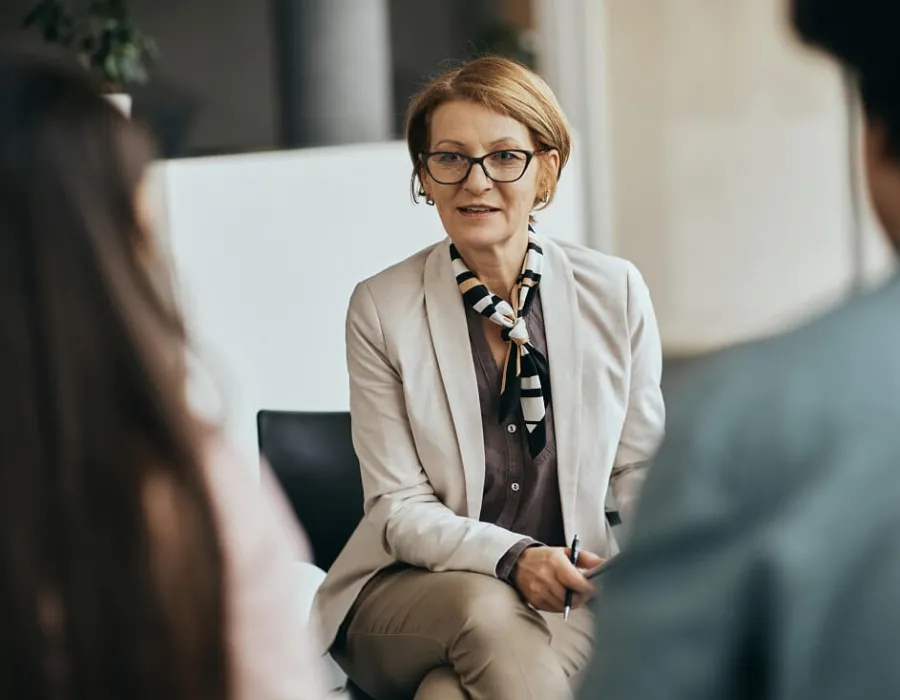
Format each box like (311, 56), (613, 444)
(512, 547), (603, 613)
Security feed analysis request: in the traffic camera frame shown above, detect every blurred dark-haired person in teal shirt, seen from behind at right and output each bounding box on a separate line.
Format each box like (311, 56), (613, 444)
(581, 0), (900, 700)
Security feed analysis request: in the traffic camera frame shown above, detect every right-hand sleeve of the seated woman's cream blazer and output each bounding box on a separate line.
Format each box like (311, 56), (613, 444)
(610, 264), (666, 521)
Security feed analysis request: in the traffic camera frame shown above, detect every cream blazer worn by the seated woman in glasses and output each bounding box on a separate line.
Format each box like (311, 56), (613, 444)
(314, 238), (665, 646)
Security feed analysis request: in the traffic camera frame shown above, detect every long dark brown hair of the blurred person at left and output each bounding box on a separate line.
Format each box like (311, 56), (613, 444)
(0, 48), (230, 700)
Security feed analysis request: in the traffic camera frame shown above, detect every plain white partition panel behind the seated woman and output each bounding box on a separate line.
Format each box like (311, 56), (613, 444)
(157, 142), (583, 468)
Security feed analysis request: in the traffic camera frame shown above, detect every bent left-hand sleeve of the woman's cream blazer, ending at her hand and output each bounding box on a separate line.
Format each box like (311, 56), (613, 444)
(347, 282), (522, 576)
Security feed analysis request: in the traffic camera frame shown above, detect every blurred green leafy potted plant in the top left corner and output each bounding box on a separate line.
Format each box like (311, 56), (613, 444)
(23, 0), (159, 113)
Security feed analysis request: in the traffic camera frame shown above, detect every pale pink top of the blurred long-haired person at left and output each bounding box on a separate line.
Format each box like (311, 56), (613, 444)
(209, 449), (325, 700)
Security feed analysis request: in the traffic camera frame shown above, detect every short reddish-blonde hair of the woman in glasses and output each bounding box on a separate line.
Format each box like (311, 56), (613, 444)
(406, 56), (572, 216)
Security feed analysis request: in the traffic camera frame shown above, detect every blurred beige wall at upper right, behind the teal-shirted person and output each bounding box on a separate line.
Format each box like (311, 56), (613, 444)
(604, 0), (885, 353)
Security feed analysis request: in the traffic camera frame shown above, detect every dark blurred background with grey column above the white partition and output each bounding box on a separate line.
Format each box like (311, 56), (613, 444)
(0, 0), (535, 158)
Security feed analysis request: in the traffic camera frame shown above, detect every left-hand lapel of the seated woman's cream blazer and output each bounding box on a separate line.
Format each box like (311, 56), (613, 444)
(424, 239), (484, 518)
